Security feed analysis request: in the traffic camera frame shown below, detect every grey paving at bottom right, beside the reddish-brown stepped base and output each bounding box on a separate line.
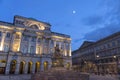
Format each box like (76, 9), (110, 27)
(90, 75), (120, 80)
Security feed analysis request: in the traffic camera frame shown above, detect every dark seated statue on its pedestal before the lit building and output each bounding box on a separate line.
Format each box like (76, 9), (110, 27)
(52, 45), (64, 67)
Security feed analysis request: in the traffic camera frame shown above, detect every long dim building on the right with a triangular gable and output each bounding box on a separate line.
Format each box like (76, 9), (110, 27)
(72, 32), (120, 74)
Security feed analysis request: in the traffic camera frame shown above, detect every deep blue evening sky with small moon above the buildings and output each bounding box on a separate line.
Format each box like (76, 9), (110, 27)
(0, 0), (120, 50)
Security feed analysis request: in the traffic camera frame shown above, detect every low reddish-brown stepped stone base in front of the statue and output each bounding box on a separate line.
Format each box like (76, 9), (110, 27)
(32, 71), (89, 80)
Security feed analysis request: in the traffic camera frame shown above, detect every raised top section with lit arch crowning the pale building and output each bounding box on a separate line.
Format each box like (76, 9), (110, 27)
(14, 16), (51, 30)
